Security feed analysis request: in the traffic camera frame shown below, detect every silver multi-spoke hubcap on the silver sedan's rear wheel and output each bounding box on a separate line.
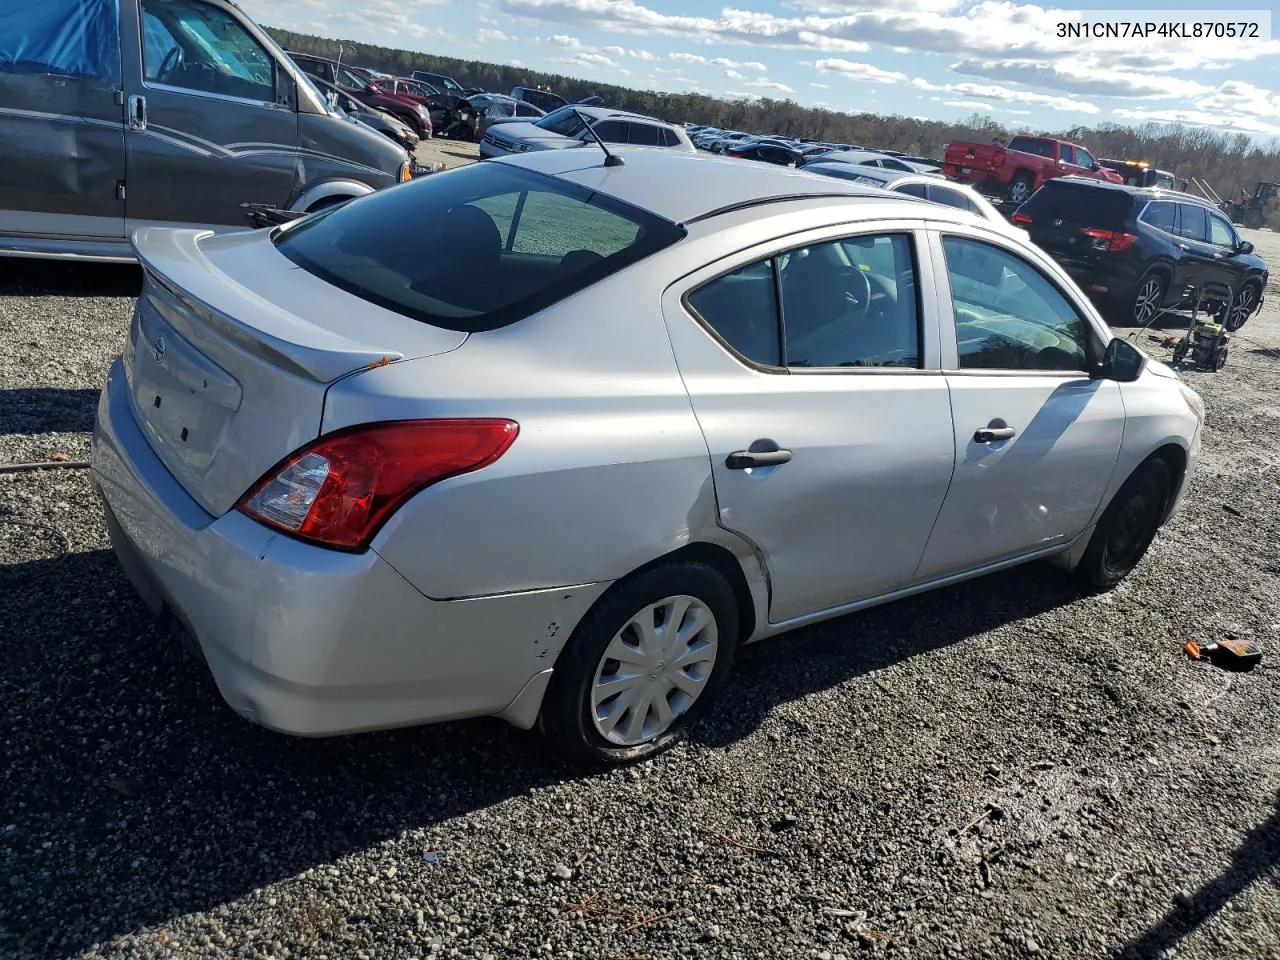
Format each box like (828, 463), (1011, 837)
(591, 595), (718, 746)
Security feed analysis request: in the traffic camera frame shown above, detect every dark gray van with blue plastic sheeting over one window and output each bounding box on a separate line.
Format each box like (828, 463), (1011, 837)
(0, 0), (413, 261)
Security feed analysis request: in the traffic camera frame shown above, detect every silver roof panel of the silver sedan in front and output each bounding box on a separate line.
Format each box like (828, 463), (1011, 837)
(485, 145), (936, 223)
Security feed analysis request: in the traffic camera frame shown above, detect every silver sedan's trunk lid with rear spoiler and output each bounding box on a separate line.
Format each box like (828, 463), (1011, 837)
(124, 228), (466, 516)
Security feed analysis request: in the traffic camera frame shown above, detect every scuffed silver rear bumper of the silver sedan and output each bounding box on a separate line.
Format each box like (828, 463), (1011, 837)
(92, 361), (608, 736)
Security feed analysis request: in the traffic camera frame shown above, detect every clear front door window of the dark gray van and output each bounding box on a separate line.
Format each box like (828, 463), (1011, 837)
(141, 0), (275, 102)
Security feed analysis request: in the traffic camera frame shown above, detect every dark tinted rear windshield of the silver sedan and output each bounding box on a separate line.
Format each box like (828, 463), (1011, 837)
(275, 163), (684, 333)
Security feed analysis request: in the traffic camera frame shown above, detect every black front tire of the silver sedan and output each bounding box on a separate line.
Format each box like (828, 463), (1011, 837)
(1075, 457), (1172, 590)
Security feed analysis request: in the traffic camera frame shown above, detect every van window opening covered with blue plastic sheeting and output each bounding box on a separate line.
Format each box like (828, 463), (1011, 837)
(0, 0), (120, 84)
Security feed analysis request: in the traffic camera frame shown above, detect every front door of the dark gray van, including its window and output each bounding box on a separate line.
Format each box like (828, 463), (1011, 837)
(124, 0), (298, 232)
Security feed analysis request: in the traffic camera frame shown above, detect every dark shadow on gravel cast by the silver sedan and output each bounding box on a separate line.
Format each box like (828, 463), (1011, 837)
(0, 545), (1079, 956)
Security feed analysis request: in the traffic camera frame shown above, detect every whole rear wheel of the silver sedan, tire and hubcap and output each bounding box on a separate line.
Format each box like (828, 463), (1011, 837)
(539, 561), (739, 767)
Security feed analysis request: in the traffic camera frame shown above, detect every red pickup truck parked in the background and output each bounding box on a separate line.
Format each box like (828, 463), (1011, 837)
(942, 137), (1124, 204)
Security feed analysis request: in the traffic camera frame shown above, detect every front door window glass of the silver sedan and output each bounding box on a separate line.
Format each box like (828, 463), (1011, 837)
(942, 237), (1091, 371)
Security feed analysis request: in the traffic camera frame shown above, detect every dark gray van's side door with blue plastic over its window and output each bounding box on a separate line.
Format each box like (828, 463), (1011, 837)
(0, 0), (124, 246)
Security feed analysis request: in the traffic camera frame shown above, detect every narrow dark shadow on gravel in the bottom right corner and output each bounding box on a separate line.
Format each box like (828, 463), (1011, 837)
(1115, 797), (1280, 960)
